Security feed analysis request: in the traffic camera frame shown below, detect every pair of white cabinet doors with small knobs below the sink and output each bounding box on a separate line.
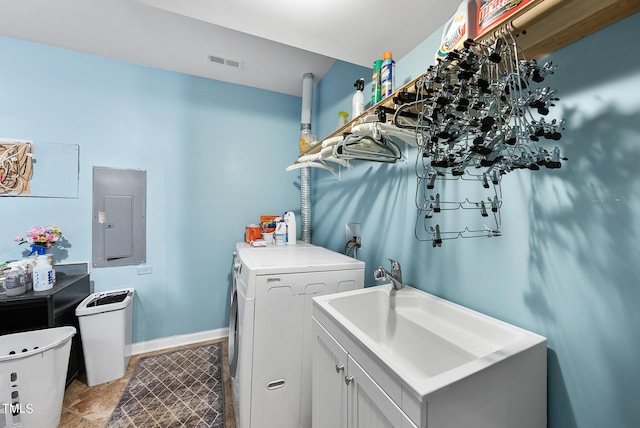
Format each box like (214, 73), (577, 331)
(312, 320), (416, 428)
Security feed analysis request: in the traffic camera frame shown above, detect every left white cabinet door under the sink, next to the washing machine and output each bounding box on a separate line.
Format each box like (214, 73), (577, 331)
(311, 319), (347, 428)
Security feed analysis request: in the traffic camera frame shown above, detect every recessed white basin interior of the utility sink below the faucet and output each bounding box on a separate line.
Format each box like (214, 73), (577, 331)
(325, 286), (526, 378)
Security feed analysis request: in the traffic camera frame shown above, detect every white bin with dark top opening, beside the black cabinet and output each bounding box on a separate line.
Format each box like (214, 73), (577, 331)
(76, 288), (134, 386)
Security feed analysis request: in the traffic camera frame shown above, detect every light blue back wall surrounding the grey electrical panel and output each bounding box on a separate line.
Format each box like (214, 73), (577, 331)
(0, 38), (302, 342)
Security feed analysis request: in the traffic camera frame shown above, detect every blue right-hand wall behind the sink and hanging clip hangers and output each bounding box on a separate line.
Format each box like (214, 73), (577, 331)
(312, 10), (640, 428)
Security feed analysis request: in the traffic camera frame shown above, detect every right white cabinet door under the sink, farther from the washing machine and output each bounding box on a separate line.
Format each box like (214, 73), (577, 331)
(348, 356), (417, 428)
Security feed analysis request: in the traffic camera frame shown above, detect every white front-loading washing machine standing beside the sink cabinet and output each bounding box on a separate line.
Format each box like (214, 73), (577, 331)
(229, 242), (364, 428)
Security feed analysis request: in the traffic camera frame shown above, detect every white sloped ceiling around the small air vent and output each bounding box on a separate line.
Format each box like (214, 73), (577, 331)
(0, 0), (459, 96)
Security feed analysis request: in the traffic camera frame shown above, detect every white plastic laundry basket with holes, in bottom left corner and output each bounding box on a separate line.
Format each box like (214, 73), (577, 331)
(0, 327), (76, 428)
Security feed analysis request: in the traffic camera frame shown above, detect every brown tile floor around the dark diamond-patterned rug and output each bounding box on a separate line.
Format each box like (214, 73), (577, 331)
(58, 338), (236, 428)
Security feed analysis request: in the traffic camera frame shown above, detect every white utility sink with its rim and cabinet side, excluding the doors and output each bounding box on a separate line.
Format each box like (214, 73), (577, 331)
(314, 284), (547, 427)
